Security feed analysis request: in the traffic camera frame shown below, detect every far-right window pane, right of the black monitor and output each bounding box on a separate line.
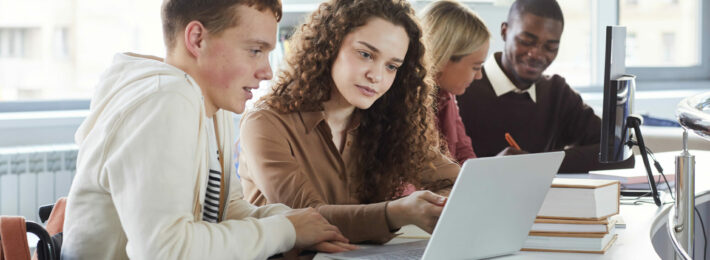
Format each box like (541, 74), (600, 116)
(619, 0), (710, 82)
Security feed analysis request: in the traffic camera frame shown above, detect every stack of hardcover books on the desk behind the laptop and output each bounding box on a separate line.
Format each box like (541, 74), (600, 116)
(522, 178), (620, 254)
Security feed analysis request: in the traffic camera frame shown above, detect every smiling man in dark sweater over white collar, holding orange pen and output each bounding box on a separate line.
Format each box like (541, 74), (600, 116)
(458, 0), (633, 173)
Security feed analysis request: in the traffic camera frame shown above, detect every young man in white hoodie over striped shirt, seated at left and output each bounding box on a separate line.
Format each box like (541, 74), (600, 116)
(62, 0), (350, 259)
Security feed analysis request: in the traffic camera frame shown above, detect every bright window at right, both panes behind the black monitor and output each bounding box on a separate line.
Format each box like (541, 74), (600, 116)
(547, 0), (710, 89)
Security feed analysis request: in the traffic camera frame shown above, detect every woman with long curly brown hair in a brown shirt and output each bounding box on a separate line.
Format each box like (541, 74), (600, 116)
(239, 0), (459, 243)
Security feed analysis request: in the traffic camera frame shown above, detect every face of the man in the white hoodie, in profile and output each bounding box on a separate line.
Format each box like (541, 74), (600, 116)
(197, 5), (277, 113)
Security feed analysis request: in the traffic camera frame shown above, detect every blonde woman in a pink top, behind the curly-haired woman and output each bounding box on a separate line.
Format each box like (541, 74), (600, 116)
(421, 1), (491, 164)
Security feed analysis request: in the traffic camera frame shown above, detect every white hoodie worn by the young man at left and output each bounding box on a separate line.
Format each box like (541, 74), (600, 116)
(62, 54), (296, 259)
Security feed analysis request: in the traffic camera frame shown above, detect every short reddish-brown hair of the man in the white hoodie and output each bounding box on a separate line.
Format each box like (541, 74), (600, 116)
(161, 0), (282, 50)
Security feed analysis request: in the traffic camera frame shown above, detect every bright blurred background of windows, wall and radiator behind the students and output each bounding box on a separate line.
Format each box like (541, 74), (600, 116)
(0, 0), (710, 220)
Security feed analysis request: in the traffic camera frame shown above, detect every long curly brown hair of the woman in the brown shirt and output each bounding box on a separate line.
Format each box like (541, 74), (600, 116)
(261, 0), (448, 203)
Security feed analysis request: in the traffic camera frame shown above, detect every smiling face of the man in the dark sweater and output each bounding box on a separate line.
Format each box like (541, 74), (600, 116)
(501, 13), (562, 84)
